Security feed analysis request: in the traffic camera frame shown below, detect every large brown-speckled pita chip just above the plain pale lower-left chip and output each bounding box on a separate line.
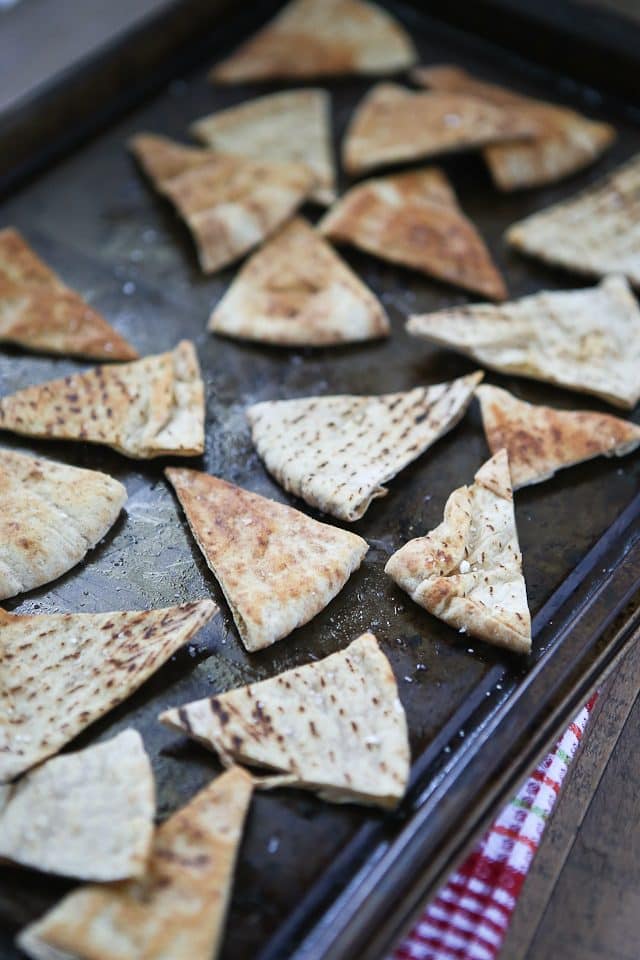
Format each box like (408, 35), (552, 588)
(0, 600), (217, 783)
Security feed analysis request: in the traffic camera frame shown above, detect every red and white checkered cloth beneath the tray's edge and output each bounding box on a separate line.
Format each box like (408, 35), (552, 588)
(389, 694), (597, 960)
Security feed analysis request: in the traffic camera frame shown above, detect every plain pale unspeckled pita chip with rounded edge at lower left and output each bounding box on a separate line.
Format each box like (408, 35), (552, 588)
(0, 729), (156, 882)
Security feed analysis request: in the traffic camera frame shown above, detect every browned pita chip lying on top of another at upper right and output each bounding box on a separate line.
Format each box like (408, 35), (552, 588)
(342, 83), (537, 174)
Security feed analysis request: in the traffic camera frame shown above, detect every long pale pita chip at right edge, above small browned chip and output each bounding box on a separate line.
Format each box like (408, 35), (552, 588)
(407, 277), (640, 409)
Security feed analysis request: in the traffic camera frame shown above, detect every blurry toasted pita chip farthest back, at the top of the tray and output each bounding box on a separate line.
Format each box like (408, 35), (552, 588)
(210, 0), (416, 83)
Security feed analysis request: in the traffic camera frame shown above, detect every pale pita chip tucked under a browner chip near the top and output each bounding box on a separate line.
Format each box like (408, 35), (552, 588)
(191, 89), (336, 205)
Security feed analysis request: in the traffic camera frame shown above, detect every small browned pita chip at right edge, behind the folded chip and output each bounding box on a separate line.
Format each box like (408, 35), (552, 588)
(477, 385), (640, 490)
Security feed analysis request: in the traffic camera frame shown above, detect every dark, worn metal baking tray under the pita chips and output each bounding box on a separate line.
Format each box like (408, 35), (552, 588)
(0, 0), (640, 960)
